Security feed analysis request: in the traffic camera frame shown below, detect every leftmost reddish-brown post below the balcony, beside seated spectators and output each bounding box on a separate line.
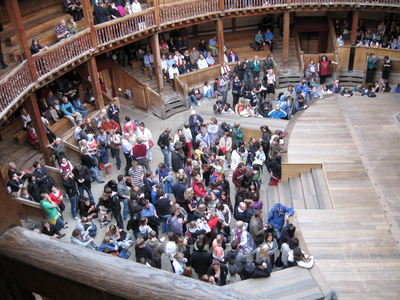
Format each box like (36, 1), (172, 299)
(25, 93), (54, 166)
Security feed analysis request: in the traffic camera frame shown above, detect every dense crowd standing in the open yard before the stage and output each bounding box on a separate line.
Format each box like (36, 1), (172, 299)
(8, 91), (314, 286)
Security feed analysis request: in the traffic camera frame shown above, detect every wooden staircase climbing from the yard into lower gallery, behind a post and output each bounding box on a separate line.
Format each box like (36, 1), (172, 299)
(125, 62), (187, 118)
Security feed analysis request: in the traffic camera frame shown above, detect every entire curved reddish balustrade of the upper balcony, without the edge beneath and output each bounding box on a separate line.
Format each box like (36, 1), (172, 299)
(0, 0), (400, 120)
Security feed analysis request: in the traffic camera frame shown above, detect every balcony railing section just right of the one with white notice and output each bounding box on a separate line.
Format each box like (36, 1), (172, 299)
(160, 0), (220, 24)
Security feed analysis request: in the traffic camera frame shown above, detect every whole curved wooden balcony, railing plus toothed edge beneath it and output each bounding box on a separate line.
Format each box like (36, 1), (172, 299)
(0, 0), (400, 124)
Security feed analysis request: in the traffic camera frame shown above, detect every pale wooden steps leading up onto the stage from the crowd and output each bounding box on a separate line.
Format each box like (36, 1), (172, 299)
(263, 168), (333, 215)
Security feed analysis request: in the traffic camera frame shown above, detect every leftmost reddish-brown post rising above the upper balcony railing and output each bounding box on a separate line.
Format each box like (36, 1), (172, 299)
(4, 0), (37, 82)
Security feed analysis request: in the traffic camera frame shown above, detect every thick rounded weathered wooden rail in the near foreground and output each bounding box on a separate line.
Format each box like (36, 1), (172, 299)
(0, 227), (256, 300)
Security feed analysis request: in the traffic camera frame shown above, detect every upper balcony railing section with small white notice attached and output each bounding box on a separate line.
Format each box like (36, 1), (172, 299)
(95, 8), (156, 46)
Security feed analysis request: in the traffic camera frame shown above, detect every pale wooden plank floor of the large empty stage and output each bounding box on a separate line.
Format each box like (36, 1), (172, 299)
(288, 94), (400, 299)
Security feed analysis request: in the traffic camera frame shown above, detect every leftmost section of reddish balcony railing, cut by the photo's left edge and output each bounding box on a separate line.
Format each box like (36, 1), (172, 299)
(0, 61), (33, 118)
